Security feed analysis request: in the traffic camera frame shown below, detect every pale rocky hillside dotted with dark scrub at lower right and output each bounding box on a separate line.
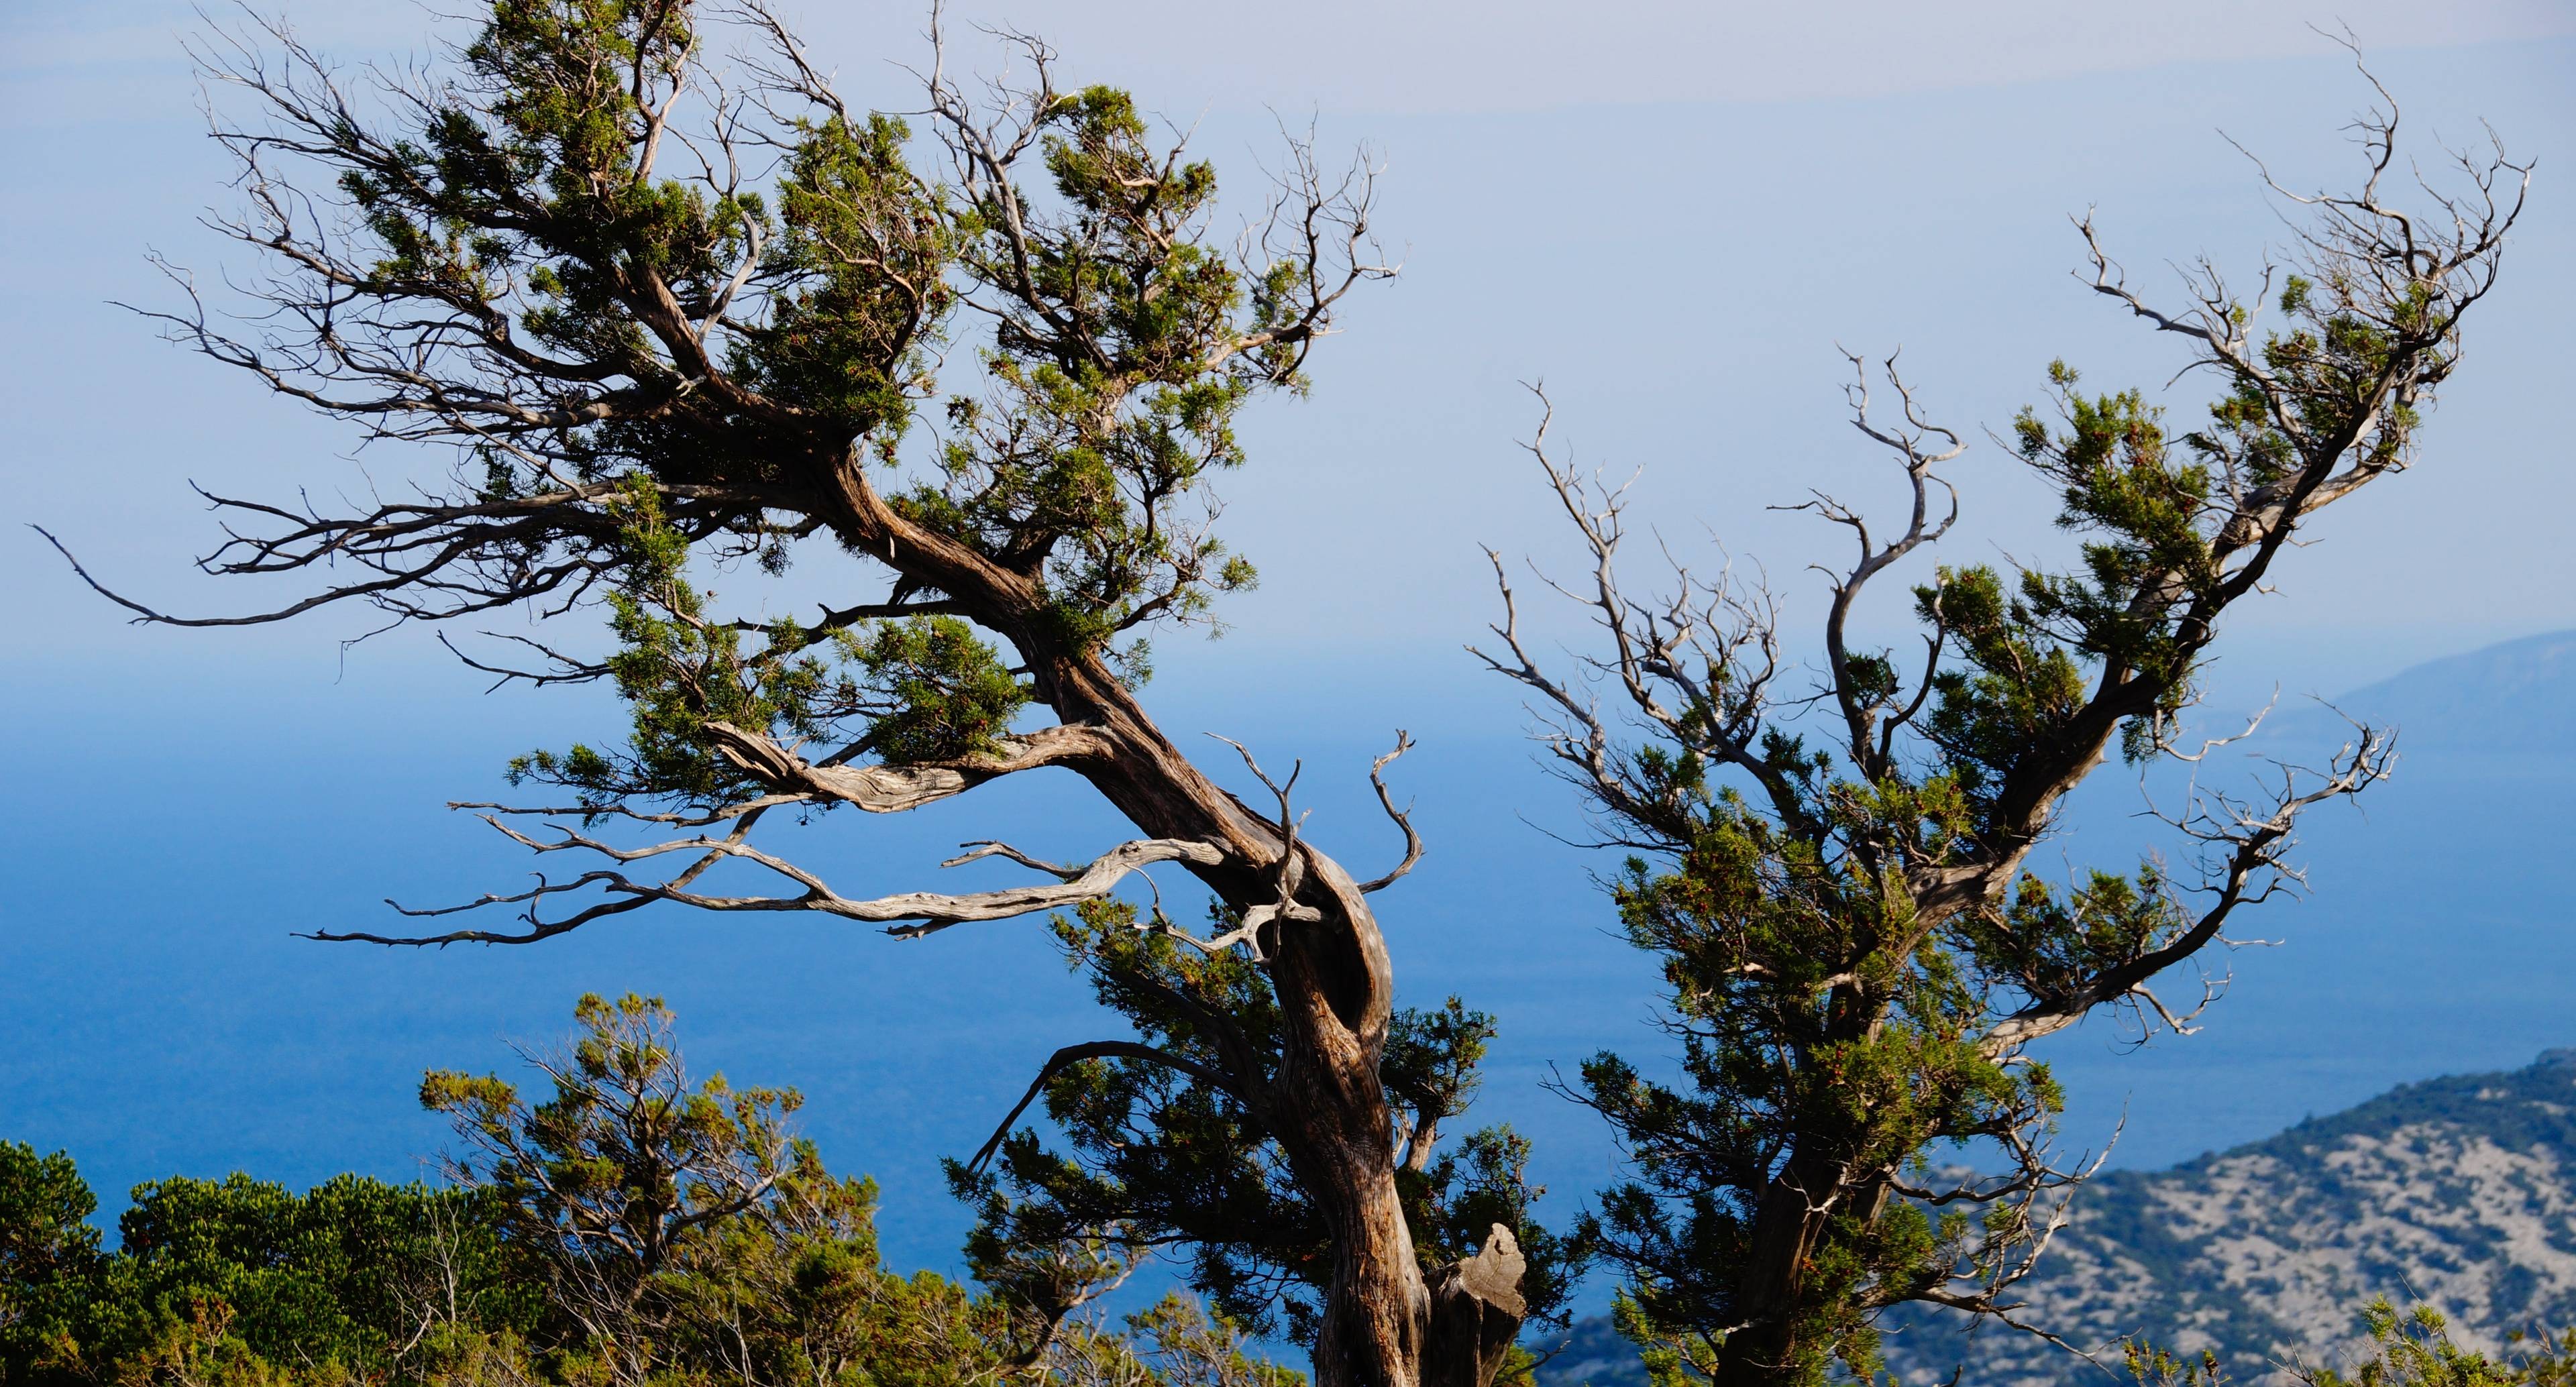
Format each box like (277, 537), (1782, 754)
(1540, 1050), (2576, 1387)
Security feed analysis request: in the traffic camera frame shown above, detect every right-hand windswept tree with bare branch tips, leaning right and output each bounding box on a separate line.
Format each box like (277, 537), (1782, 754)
(1487, 62), (2530, 1384)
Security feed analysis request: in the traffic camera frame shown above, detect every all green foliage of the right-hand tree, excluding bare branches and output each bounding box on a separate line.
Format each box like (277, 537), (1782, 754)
(1576, 380), (2277, 1382)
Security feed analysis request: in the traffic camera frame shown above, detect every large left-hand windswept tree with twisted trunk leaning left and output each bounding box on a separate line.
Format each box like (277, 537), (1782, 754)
(45, 0), (1556, 1387)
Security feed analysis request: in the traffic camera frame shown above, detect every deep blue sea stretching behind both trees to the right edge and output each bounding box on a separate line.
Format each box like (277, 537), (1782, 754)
(0, 641), (2576, 1327)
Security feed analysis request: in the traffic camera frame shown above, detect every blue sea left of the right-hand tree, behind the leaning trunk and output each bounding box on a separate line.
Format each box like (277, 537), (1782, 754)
(0, 656), (1649, 1286)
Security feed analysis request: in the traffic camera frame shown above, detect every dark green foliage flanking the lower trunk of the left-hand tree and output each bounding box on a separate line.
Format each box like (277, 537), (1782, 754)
(948, 901), (1574, 1338)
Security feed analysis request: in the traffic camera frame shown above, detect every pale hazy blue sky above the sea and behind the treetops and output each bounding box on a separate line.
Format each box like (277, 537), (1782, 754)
(0, 0), (2576, 687)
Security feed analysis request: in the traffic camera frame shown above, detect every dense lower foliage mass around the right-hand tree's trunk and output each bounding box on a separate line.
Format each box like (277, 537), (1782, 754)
(1576, 795), (2061, 1379)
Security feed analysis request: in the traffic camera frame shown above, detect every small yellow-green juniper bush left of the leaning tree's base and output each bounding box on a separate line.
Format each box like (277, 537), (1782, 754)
(420, 996), (1046, 1387)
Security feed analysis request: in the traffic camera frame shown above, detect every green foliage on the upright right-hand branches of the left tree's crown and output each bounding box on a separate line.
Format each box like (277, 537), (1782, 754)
(899, 87), (1267, 643)
